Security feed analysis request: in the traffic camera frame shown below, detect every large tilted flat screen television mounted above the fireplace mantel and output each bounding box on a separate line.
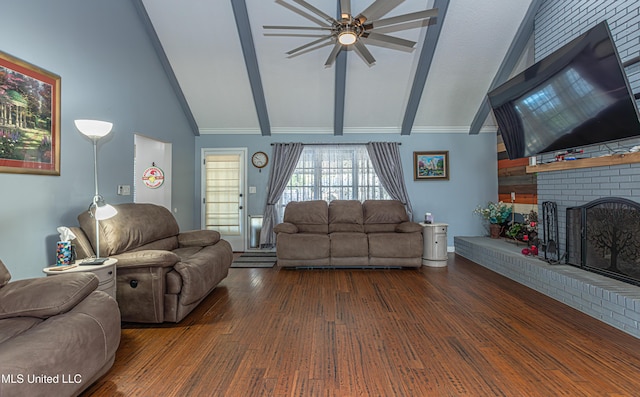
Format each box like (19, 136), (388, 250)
(488, 22), (640, 159)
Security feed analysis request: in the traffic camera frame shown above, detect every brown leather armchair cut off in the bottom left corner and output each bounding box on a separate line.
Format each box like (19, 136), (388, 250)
(0, 261), (120, 397)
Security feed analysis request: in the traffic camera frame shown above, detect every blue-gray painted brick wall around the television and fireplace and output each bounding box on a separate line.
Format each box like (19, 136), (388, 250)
(535, 0), (640, 254)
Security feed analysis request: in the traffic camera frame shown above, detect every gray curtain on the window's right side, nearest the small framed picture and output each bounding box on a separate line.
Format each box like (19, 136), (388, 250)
(367, 142), (413, 219)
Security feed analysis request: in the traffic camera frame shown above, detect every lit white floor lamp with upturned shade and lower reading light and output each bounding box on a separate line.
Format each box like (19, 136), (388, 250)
(74, 120), (118, 265)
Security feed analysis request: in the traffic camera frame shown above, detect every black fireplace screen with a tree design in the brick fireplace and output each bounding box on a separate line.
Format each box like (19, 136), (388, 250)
(567, 198), (640, 285)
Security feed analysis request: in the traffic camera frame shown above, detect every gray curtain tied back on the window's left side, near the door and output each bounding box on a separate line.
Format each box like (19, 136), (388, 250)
(260, 143), (304, 248)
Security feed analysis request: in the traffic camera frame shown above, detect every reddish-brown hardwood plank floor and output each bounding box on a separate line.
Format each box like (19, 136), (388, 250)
(84, 254), (640, 396)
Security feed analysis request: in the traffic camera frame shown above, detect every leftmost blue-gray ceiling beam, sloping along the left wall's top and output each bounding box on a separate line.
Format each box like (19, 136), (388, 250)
(133, 0), (200, 136)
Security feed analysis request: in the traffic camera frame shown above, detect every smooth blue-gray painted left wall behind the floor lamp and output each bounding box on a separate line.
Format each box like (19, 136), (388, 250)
(0, 0), (197, 279)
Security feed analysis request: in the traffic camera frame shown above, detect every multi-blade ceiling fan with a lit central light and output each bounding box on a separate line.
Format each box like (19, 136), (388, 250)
(263, 0), (438, 67)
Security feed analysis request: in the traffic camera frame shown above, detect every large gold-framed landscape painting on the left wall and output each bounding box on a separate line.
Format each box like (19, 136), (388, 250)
(0, 51), (60, 175)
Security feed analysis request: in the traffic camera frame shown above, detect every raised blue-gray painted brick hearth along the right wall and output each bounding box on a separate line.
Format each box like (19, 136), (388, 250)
(454, 237), (640, 338)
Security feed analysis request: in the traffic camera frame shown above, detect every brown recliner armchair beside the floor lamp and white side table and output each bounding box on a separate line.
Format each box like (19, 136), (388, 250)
(72, 203), (233, 323)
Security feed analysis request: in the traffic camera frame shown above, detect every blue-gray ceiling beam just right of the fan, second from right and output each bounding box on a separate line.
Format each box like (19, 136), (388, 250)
(400, 0), (449, 135)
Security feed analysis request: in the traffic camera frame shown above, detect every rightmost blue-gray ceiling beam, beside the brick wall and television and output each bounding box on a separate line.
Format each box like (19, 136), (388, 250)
(469, 0), (542, 135)
